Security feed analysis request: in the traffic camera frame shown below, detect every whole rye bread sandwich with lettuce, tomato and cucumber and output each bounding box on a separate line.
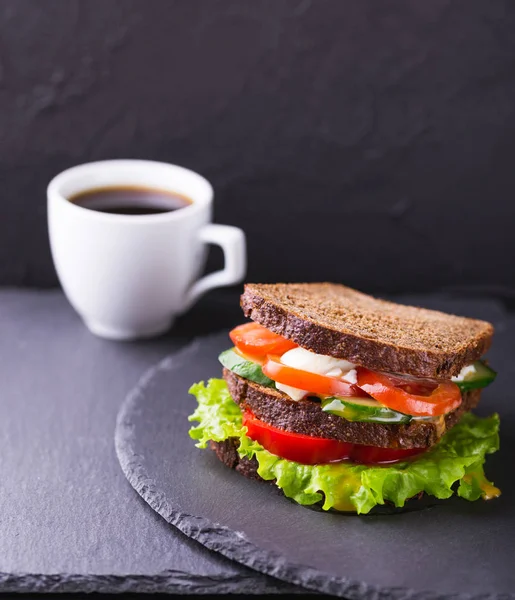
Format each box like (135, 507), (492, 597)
(189, 283), (500, 514)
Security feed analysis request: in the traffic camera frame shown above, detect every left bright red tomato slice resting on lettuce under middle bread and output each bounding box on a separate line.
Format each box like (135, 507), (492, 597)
(243, 411), (353, 465)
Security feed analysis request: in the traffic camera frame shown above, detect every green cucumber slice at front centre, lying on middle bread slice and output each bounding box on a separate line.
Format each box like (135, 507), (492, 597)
(322, 397), (413, 424)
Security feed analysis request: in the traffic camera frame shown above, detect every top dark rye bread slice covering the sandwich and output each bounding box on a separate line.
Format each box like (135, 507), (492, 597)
(241, 283), (494, 379)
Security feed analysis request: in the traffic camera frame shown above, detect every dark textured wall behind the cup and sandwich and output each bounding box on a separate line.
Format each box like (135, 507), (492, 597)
(0, 0), (515, 294)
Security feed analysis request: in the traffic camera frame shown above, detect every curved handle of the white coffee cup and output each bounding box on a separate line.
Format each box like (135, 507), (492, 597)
(182, 223), (247, 312)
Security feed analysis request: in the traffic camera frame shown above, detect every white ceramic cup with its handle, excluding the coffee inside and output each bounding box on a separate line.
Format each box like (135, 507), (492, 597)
(47, 160), (246, 340)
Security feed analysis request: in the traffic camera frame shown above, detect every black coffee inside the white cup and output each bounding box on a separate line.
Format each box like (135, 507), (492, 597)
(69, 186), (192, 215)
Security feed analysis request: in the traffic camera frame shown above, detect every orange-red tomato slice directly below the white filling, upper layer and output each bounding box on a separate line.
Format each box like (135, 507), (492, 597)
(262, 356), (368, 397)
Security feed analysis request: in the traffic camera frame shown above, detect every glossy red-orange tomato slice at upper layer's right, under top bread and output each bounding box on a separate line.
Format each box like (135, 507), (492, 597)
(357, 367), (461, 417)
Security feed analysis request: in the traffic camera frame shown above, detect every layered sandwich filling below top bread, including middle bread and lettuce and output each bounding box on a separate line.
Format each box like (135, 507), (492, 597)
(190, 322), (499, 513)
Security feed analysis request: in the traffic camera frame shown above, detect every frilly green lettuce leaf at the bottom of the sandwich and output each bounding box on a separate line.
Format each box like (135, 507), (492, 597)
(189, 379), (500, 514)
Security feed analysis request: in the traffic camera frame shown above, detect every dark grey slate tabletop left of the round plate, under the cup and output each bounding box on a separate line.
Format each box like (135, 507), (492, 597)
(0, 290), (299, 594)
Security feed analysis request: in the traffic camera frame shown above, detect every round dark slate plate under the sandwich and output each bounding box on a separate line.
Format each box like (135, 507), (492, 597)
(116, 333), (515, 600)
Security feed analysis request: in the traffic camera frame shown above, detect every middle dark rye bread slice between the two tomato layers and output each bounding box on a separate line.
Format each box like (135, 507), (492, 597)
(223, 369), (481, 448)
